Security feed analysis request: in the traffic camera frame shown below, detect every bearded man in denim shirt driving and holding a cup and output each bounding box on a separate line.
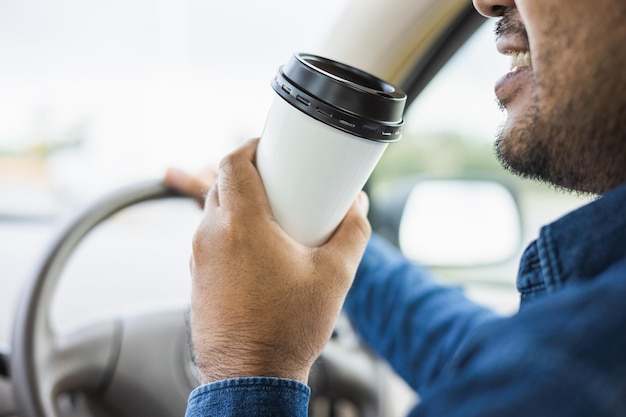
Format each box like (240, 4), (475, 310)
(168, 0), (626, 417)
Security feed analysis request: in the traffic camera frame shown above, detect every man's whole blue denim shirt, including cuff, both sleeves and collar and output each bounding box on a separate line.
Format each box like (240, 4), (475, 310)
(187, 186), (626, 417)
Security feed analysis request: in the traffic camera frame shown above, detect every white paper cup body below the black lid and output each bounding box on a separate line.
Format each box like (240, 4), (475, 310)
(256, 95), (387, 246)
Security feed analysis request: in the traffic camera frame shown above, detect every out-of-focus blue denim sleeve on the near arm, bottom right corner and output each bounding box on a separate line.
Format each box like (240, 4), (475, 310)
(411, 260), (626, 417)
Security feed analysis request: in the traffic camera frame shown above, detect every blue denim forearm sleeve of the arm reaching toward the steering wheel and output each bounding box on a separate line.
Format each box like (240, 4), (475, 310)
(344, 236), (498, 392)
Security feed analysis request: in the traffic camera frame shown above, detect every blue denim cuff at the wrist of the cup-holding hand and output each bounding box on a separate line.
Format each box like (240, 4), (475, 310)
(185, 377), (311, 417)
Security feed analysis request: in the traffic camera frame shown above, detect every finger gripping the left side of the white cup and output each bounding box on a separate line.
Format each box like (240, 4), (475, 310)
(217, 139), (269, 213)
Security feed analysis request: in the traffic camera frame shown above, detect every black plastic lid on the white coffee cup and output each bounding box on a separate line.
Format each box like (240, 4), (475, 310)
(272, 53), (406, 142)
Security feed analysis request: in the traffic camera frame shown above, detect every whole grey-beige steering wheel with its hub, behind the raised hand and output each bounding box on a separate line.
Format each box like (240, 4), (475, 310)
(11, 181), (388, 417)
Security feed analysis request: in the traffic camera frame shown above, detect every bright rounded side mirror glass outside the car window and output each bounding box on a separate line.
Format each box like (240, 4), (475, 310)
(398, 179), (522, 267)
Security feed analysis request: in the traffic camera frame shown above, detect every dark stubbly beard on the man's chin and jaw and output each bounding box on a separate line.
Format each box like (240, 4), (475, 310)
(495, 90), (626, 194)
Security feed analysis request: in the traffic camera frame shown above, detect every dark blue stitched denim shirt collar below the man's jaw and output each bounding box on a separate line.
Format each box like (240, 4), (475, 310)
(517, 184), (626, 299)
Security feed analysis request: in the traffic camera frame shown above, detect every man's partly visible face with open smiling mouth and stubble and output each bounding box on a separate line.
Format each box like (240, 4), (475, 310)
(474, 0), (626, 193)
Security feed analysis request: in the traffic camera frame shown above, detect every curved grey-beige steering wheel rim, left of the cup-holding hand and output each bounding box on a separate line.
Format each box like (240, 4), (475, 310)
(11, 181), (183, 417)
